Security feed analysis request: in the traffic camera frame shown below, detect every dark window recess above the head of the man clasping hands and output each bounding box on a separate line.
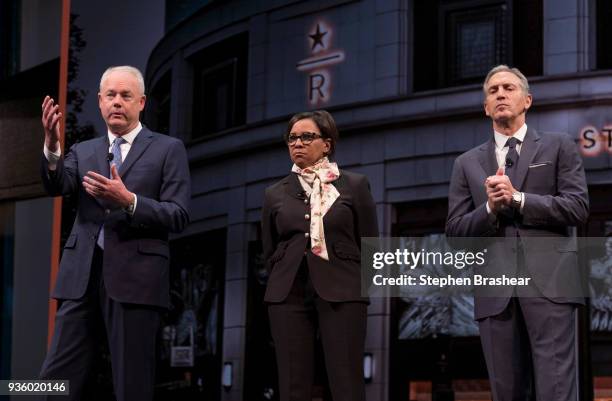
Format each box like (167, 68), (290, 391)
(413, 0), (540, 92)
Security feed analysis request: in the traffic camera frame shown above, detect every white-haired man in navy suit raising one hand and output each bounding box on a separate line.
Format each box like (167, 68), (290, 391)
(40, 66), (191, 401)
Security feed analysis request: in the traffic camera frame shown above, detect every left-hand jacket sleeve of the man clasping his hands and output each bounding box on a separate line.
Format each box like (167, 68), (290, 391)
(446, 158), (497, 237)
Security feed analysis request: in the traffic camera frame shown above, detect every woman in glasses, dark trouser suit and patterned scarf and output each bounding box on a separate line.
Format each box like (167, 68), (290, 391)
(262, 110), (378, 401)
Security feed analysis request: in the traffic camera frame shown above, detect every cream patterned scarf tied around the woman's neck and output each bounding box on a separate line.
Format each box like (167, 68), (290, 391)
(291, 157), (340, 260)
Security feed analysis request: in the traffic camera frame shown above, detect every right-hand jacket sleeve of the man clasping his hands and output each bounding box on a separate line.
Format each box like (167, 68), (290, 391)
(523, 135), (589, 226)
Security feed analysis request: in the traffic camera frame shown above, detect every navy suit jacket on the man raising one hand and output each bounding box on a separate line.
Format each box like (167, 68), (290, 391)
(42, 127), (191, 307)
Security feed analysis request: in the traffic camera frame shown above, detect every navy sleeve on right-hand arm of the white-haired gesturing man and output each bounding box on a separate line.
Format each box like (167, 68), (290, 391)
(131, 141), (191, 232)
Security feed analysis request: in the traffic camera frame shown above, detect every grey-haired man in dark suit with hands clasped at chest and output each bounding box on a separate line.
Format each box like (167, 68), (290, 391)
(446, 65), (589, 401)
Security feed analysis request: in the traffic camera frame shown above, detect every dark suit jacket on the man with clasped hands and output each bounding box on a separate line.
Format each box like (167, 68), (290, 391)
(446, 128), (589, 319)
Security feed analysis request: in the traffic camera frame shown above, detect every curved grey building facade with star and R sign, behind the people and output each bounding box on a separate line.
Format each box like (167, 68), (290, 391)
(145, 0), (612, 400)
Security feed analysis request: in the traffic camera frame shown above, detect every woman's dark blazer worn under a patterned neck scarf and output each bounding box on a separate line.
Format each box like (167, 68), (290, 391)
(262, 170), (378, 302)
